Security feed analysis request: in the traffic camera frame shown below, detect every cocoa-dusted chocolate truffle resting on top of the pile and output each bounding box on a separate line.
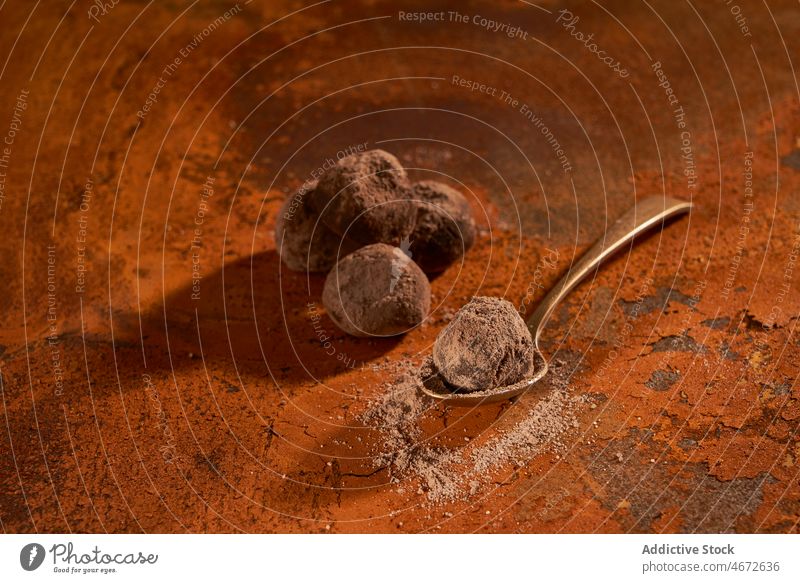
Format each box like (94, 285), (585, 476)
(310, 150), (416, 245)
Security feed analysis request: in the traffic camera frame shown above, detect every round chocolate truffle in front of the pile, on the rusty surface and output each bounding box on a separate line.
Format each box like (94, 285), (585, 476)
(322, 243), (431, 336)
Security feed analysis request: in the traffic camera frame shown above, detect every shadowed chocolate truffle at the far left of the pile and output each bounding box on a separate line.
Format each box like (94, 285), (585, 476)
(275, 183), (358, 273)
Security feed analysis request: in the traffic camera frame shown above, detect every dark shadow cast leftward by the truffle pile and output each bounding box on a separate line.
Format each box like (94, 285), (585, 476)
(122, 250), (398, 383)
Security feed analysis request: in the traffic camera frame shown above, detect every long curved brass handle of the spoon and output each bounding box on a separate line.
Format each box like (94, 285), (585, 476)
(528, 196), (692, 344)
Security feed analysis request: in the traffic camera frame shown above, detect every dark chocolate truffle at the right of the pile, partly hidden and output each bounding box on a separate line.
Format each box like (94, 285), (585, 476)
(411, 180), (475, 273)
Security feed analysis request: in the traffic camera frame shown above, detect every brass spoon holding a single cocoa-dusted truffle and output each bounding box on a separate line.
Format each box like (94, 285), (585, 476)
(420, 196), (692, 406)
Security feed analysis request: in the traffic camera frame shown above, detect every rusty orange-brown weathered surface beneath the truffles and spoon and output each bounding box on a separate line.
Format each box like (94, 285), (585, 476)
(0, 0), (800, 532)
